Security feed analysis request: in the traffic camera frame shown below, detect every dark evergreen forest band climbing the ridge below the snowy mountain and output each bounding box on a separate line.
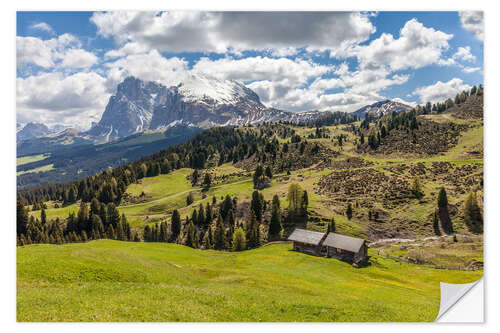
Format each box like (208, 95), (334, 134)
(17, 123), (328, 209)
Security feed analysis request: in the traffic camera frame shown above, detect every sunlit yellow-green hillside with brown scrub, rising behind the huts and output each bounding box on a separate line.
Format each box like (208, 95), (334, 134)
(32, 109), (483, 240)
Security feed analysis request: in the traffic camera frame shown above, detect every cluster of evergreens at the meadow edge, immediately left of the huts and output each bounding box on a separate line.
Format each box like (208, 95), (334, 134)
(139, 184), (308, 251)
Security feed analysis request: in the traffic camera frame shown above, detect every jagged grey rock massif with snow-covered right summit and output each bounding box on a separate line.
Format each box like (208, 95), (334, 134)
(89, 75), (326, 140)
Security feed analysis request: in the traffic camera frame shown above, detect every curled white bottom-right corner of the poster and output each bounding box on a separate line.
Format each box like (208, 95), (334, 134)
(436, 278), (484, 323)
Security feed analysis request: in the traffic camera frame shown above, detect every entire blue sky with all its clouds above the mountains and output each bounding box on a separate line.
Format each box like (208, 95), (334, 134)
(17, 12), (483, 129)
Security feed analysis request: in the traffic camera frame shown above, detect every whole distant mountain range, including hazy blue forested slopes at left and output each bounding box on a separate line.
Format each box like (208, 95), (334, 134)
(17, 75), (411, 186)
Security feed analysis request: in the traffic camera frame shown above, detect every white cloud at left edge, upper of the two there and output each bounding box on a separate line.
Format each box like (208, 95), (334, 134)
(16, 34), (99, 69)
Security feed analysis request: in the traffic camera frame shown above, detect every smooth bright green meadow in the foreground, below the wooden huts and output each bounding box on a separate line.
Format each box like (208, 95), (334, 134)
(17, 240), (482, 321)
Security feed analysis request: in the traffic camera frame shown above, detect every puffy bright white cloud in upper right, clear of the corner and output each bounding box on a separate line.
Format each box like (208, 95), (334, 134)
(348, 19), (453, 71)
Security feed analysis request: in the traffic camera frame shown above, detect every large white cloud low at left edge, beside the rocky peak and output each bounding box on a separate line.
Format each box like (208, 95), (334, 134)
(16, 73), (110, 127)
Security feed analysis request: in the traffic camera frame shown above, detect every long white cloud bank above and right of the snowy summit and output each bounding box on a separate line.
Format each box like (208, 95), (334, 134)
(188, 56), (402, 111)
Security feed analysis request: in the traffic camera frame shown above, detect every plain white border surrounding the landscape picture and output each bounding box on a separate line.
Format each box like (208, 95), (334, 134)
(0, 0), (500, 333)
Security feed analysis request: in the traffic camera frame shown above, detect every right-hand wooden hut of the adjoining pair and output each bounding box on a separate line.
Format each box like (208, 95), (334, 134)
(322, 232), (368, 263)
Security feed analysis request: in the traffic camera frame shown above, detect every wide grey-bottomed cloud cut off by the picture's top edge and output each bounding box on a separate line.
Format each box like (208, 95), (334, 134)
(91, 11), (375, 53)
